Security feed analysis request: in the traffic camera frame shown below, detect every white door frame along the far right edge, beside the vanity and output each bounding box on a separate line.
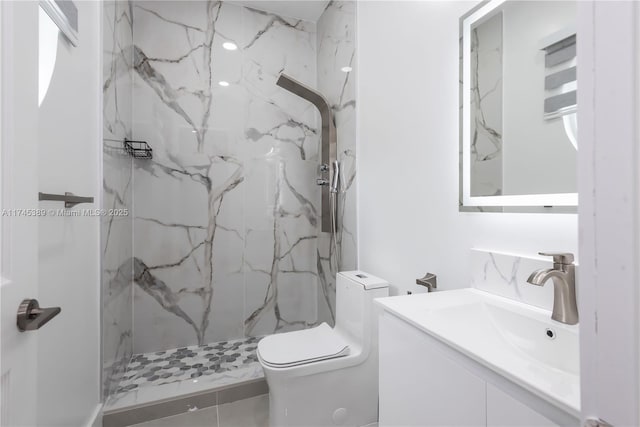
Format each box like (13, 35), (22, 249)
(577, 1), (640, 426)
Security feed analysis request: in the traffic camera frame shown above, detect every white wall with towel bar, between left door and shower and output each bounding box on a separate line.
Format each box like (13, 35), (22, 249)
(36, 2), (102, 426)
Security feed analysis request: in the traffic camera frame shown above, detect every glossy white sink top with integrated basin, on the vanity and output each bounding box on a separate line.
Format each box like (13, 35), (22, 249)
(376, 288), (580, 416)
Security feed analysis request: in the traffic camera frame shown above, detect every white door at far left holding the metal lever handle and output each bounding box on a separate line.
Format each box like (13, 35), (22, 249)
(0, 1), (40, 426)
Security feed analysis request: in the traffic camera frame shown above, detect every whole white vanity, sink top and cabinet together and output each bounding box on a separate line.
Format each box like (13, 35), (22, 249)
(377, 288), (580, 427)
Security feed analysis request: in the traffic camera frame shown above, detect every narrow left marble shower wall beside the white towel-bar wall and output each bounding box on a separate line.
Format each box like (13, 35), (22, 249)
(101, 0), (133, 396)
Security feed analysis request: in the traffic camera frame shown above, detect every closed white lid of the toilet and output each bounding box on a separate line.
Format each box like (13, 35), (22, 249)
(258, 323), (349, 368)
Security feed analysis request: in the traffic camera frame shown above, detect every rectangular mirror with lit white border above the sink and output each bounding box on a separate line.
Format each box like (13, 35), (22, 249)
(460, 0), (578, 212)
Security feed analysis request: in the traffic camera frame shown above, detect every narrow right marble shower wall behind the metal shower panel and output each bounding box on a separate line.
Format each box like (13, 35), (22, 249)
(317, 1), (357, 324)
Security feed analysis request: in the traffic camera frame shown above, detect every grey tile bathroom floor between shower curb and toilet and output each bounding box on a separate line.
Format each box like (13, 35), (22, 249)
(131, 394), (269, 427)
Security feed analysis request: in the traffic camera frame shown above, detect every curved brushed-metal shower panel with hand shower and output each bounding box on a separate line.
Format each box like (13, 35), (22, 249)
(276, 73), (340, 234)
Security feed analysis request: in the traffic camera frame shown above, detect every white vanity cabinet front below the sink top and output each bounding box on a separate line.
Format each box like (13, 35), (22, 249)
(379, 311), (579, 427)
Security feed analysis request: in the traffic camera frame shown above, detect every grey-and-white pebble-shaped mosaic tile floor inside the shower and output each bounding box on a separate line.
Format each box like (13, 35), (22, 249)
(116, 337), (261, 394)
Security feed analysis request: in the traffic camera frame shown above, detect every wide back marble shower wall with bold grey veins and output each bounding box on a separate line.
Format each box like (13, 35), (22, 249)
(132, 1), (355, 353)
